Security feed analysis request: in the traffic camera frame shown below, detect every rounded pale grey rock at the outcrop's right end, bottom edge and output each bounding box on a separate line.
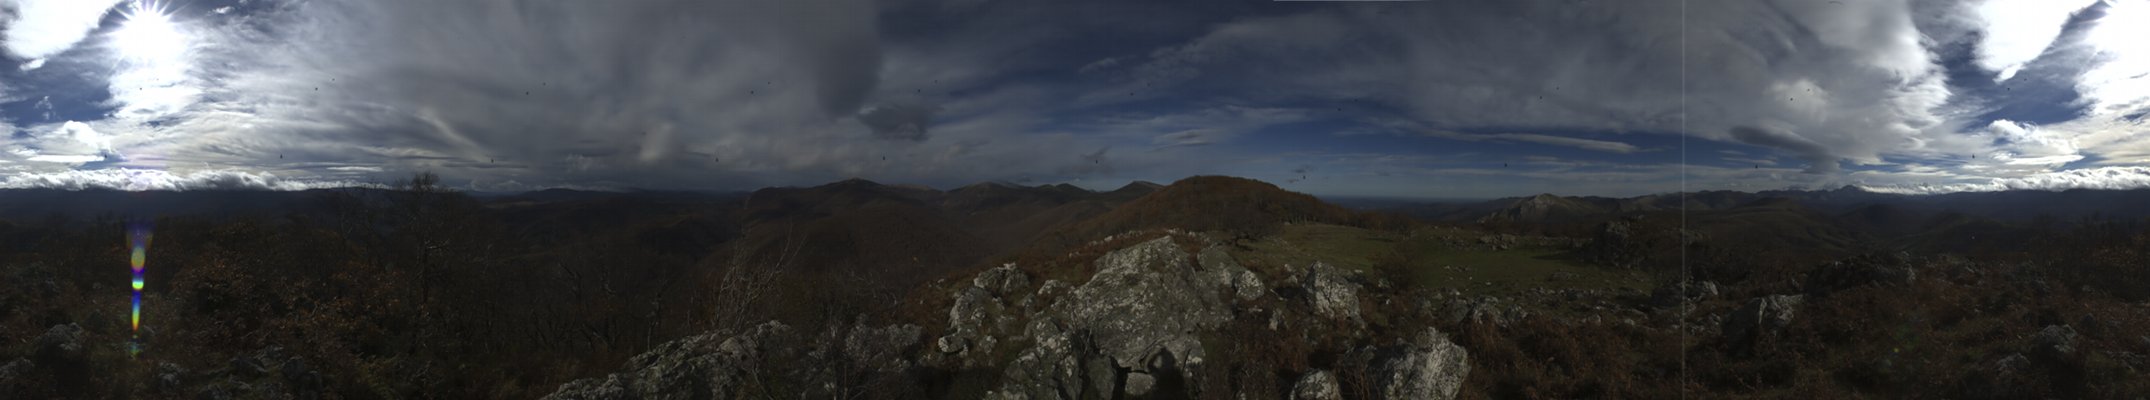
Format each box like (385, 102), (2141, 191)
(1374, 327), (1471, 398)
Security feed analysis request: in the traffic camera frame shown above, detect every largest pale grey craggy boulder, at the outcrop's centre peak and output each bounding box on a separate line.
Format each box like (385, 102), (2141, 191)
(993, 237), (1266, 398)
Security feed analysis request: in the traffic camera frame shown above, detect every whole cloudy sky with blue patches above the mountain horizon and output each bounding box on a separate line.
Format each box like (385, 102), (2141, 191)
(0, 0), (2150, 198)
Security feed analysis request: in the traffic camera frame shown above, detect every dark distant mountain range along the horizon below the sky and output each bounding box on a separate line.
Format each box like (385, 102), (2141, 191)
(0, 176), (2150, 262)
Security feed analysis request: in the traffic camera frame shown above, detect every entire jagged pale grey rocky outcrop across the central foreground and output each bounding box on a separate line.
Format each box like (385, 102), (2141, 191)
(548, 234), (1468, 400)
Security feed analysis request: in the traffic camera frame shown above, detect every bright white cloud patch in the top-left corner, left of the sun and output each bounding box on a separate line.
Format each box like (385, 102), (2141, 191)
(0, 0), (120, 61)
